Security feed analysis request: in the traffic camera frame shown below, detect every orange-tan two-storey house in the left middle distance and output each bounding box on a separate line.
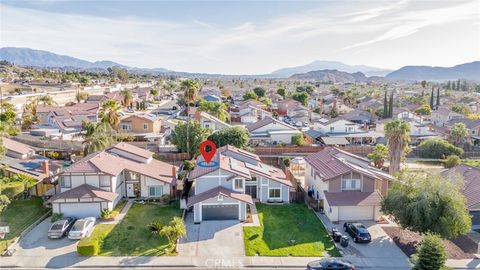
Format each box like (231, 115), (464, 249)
(117, 114), (164, 140)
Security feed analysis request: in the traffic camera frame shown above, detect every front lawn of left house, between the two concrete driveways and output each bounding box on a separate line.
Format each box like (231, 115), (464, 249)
(97, 202), (182, 256)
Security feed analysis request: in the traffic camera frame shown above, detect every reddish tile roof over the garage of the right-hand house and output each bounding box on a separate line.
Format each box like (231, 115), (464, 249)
(323, 191), (382, 206)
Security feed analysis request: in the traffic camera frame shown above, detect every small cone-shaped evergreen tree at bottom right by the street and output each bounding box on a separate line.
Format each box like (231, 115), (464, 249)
(413, 233), (447, 270)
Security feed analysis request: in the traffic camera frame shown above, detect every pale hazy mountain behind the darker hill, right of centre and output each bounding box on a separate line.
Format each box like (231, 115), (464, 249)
(271, 61), (392, 77)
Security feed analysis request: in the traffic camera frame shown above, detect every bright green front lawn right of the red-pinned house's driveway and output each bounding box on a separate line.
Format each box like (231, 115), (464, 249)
(243, 204), (340, 257)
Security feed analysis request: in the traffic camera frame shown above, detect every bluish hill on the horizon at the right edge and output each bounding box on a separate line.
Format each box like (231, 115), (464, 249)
(385, 61), (480, 81)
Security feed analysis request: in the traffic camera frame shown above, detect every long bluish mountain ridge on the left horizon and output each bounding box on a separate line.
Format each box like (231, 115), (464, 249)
(0, 47), (169, 72)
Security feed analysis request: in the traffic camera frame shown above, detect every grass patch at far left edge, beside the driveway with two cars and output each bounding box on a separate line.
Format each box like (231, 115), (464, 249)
(0, 197), (49, 253)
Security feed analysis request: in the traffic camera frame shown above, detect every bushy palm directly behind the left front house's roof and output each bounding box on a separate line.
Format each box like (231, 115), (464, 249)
(81, 122), (115, 155)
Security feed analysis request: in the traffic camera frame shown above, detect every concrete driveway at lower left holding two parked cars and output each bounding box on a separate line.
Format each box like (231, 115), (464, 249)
(7, 218), (86, 268)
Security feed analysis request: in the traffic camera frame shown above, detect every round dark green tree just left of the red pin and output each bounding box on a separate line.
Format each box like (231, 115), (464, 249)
(171, 121), (211, 156)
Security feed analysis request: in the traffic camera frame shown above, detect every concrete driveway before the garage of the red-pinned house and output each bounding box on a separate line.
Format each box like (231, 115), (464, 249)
(178, 212), (245, 259)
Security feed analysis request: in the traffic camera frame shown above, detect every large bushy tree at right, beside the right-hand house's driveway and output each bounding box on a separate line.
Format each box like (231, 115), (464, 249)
(381, 170), (471, 239)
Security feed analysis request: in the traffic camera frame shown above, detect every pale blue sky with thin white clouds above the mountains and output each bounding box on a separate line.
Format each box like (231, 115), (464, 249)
(0, 0), (480, 74)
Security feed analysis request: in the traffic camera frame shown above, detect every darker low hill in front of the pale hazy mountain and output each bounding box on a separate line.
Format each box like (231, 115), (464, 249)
(289, 69), (368, 83)
